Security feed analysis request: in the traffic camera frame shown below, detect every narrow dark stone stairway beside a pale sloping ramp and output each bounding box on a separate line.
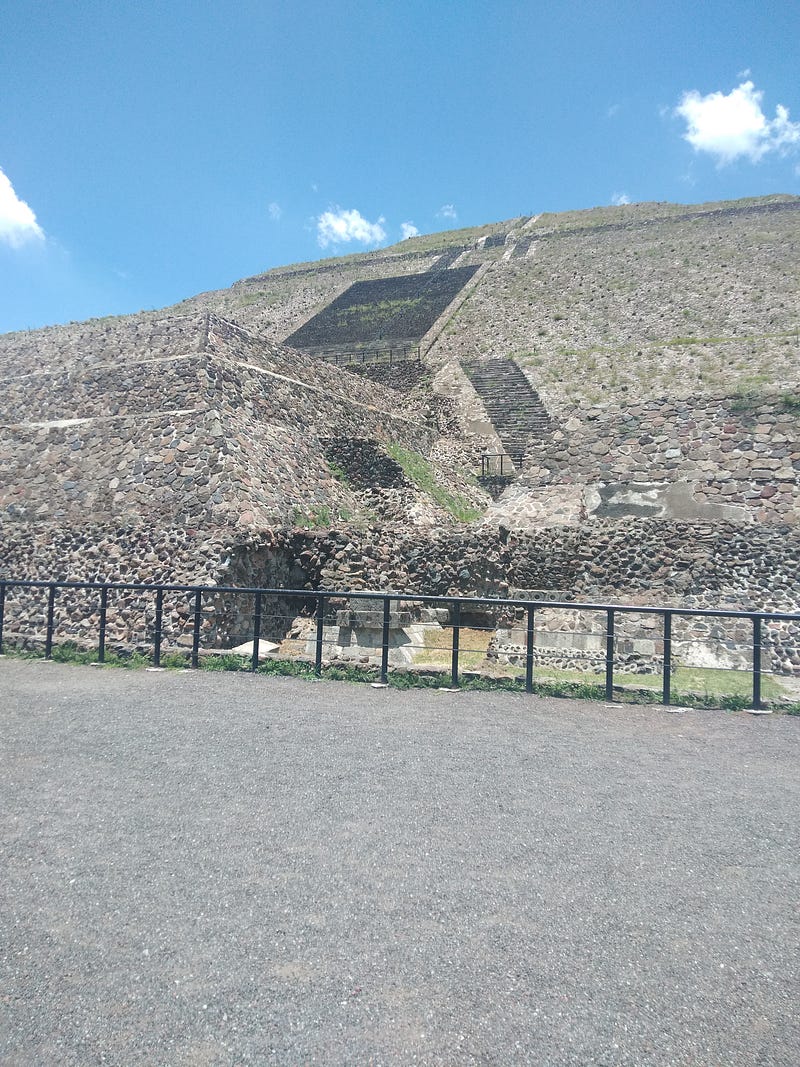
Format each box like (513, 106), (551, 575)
(463, 357), (553, 469)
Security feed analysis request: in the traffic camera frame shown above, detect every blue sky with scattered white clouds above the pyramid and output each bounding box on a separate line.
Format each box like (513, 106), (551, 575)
(0, 0), (800, 332)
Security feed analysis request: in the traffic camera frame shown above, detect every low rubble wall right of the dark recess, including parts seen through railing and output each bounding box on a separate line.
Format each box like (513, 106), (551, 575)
(307, 520), (800, 673)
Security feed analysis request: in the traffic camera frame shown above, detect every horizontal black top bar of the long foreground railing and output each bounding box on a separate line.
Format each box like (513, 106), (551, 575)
(0, 578), (800, 622)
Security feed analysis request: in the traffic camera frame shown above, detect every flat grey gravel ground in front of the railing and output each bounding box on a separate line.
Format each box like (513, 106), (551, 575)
(0, 659), (800, 1067)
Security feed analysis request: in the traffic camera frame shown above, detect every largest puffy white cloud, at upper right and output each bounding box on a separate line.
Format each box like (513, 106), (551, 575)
(675, 81), (800, 166)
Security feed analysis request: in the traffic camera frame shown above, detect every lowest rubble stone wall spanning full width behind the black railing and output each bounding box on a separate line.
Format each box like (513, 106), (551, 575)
(0, 520), (800, 674)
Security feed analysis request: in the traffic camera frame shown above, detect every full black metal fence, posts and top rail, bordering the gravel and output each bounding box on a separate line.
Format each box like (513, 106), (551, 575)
(0, 578), (800, 708)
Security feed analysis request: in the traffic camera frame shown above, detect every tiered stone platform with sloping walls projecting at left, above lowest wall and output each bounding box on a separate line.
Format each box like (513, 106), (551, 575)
(0, 317), (445, 526)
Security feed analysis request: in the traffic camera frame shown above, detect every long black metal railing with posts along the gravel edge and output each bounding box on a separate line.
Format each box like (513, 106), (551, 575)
(0, 578), (800, 708)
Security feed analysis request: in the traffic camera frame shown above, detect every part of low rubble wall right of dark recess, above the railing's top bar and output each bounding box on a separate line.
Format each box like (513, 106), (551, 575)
(315, 520), (800, 611)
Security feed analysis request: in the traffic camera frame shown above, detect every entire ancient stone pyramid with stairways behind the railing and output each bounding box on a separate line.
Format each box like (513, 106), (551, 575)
(0, 197), (800, 673)
